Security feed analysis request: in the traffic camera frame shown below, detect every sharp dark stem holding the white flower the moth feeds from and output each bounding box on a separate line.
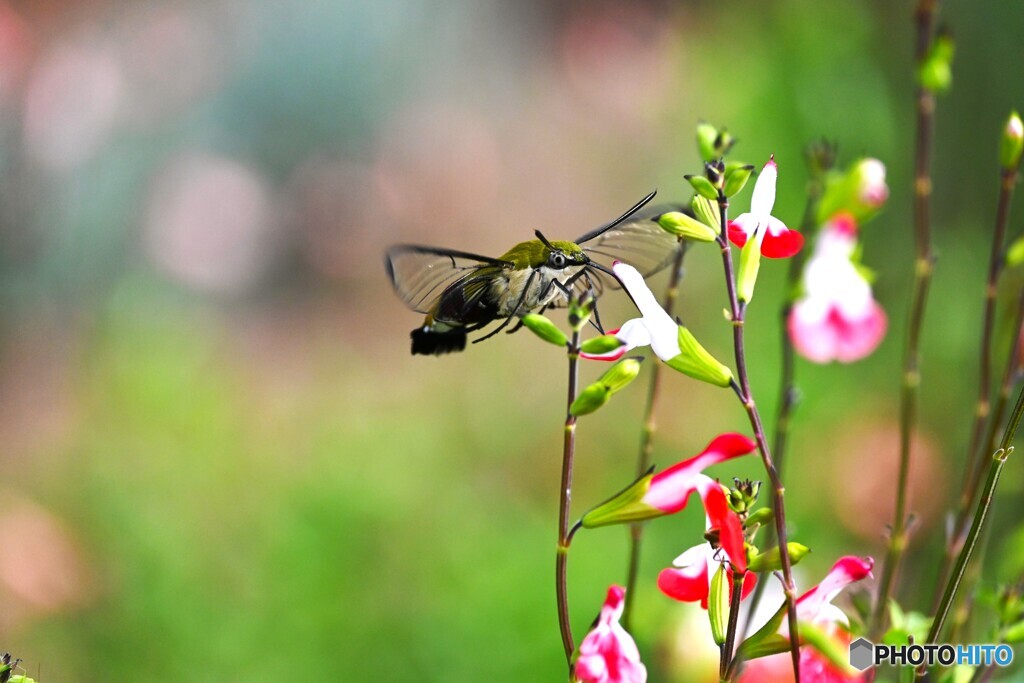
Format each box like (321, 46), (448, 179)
(718, 190), (800, 683)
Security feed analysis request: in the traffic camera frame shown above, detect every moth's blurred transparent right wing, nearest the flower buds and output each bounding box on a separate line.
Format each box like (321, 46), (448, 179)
(577, 205), (689, 288)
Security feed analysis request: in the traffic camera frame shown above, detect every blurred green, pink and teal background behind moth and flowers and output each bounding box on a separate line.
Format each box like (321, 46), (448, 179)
(0, 0), (1024, 682)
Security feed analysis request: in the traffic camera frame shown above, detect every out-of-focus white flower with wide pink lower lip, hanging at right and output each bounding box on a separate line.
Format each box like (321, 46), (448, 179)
(787, 214), (888, 362)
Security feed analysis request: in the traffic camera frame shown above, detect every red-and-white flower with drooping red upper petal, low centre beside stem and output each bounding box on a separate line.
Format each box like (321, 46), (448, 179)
(657, 483), (757, 609)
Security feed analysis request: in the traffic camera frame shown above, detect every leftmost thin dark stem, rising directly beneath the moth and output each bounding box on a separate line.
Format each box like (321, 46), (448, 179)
(555, 327), (580, 667)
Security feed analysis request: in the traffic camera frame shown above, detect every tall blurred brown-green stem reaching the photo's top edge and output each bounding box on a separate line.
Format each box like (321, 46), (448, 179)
(870, 0), (936, 639)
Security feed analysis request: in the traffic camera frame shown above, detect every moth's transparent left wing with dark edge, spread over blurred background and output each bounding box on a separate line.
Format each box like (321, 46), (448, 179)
(384, 245), (512, 313)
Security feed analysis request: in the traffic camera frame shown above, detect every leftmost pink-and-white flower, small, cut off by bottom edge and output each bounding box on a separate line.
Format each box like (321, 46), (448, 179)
(575, 586), (647, 683)
